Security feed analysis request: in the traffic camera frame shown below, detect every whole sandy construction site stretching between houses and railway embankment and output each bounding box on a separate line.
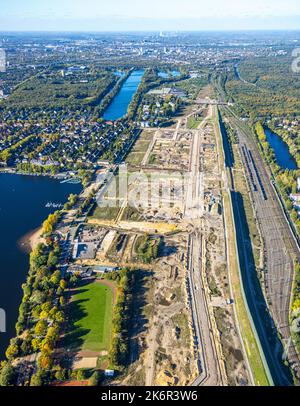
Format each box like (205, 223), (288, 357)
(68, 94), (251, 386)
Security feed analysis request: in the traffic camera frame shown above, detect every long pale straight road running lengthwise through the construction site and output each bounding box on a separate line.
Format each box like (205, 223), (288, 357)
(185, 106), (224, 386)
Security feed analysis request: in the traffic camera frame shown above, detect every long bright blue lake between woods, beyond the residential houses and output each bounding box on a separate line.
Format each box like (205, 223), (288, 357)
(103, 70), (145, 121)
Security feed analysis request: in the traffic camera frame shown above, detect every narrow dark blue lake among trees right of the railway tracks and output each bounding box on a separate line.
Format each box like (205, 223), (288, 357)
(265, 128), (298, 170)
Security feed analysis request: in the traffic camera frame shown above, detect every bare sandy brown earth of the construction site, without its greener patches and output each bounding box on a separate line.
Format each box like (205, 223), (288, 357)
(93, 100), (249, 386)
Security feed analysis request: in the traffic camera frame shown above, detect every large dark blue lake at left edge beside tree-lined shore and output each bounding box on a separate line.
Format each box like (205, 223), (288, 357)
(0, 173), (82, 359)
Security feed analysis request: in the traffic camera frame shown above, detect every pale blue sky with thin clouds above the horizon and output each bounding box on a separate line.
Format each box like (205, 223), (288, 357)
(0, 0), (300, 31)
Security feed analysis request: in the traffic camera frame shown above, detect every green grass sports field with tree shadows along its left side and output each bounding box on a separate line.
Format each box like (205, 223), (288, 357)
(66, 282), (113, 351)
